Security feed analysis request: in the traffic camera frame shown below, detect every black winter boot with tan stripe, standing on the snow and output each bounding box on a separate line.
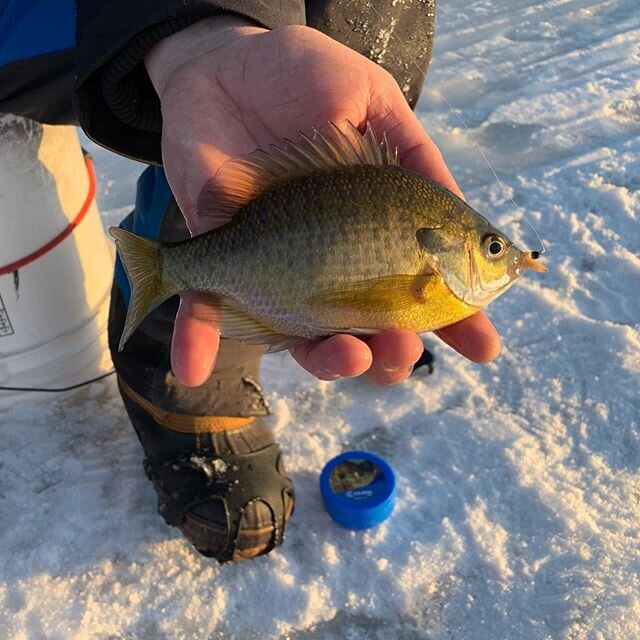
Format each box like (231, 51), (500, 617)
(109, 199), (294, 562)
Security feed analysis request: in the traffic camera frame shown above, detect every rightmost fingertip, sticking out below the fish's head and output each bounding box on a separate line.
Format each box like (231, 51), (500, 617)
(435, 311), (500, 364)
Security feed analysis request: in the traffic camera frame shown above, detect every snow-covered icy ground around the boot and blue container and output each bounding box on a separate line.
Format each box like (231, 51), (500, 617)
(0, 0), (640, 640)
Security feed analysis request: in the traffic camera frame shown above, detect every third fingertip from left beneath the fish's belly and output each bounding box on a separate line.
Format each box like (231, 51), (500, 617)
(366, 329), (424, 385)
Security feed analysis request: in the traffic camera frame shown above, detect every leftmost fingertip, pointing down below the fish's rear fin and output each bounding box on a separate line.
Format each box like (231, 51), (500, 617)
(171, 294), (220, 387)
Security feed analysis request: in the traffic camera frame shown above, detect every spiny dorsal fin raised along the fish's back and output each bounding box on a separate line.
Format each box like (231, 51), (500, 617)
(198, 121), (399, 224)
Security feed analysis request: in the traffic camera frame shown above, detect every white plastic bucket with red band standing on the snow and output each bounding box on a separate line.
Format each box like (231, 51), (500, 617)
(0, 115), (114, 393)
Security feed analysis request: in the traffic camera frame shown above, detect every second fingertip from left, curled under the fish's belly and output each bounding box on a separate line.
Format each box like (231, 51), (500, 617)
(291, 334), (373, 380)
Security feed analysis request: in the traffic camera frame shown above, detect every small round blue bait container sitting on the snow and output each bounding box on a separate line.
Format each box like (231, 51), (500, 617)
(320, 451), (396, 529)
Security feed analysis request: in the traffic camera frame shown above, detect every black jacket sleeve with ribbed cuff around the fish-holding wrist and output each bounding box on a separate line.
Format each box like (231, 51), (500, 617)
(74, 0), (305, 164)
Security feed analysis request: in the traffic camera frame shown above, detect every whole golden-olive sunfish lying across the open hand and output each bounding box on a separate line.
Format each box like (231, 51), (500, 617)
(110, 124), (546, 351)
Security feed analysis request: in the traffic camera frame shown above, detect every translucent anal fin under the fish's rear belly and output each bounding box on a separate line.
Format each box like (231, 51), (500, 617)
(191, 295), (304, 352)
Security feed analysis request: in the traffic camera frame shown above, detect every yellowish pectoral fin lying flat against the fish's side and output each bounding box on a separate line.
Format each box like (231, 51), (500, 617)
(306, 273), (433, 311)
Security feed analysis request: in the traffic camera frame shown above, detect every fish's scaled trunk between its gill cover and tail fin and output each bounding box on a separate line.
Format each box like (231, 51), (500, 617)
(163, 166), (475, 338)
